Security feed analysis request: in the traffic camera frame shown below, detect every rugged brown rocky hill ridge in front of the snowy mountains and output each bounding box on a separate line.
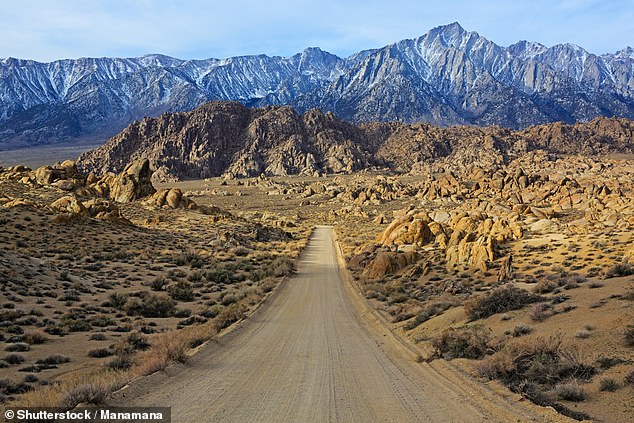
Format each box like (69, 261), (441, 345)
(78, 102), (634, 180)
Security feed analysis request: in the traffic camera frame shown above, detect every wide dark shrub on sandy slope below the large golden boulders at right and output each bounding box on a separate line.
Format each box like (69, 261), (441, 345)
(465, 285), (544, 320)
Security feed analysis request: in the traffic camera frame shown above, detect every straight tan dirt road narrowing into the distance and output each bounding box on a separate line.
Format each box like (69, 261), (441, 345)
(112, 227), (563, 423)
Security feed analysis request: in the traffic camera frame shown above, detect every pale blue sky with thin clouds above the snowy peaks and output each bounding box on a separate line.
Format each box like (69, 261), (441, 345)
(0, 0), (634, 61)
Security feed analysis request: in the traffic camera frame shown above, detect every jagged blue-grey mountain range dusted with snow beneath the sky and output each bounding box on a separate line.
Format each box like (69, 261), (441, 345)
(0, 23), (634, 149)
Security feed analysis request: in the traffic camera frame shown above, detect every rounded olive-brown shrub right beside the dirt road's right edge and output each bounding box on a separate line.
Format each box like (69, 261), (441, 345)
(432, 326), (490, 360)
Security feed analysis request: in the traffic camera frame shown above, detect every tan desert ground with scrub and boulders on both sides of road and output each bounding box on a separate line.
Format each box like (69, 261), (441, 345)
(0, 153), (634, 422)
